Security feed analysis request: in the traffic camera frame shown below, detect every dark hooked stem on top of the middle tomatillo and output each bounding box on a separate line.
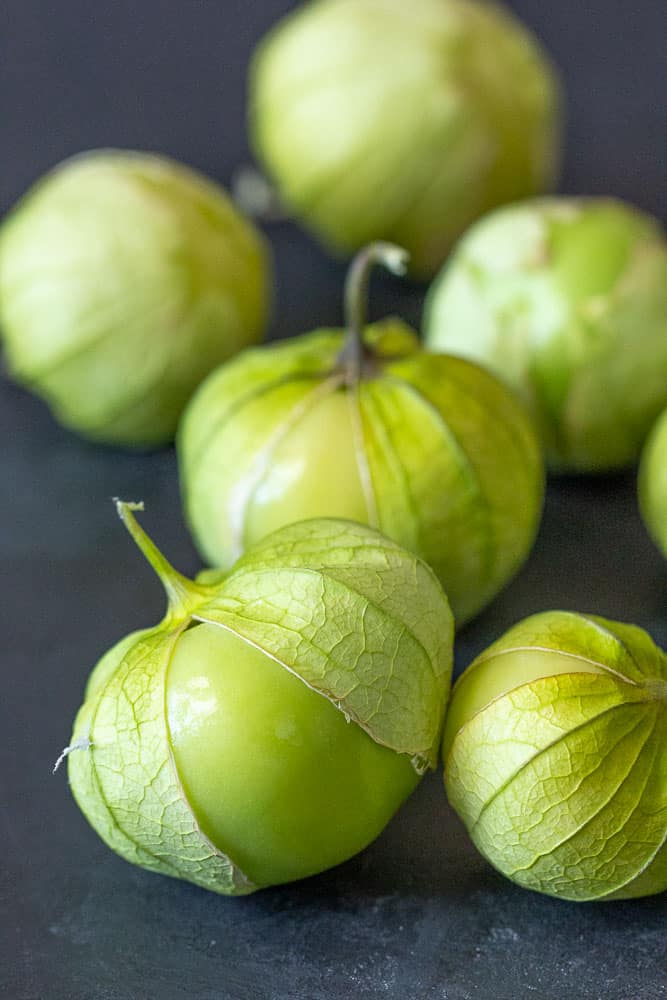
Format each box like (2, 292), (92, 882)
(338, 242), (410, 384)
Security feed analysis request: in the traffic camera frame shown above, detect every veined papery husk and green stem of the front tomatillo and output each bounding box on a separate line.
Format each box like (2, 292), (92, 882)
(69, 505), (453, 895)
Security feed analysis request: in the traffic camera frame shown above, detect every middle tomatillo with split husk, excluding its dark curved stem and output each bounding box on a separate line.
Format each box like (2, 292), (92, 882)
(178, 320), (543, 626)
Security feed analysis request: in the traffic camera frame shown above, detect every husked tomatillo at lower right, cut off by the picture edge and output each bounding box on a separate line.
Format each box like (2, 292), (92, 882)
(443, 612), (667, 901)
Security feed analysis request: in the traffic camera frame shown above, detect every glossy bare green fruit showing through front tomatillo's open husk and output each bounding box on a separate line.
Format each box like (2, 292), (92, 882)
(167, 625), (419, 886)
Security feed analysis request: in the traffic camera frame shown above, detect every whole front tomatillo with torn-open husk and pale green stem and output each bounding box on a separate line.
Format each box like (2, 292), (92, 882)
(65, 503), (453, 895)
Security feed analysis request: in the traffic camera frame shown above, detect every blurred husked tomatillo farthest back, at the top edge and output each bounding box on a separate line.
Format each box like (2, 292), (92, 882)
(249, 0), (560, 278)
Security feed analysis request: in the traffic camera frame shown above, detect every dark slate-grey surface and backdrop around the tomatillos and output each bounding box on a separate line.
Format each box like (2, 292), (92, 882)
(0, 0), (667, 1000)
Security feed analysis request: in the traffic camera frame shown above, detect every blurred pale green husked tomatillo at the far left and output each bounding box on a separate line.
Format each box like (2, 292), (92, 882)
(0, 150), (270, 447)
